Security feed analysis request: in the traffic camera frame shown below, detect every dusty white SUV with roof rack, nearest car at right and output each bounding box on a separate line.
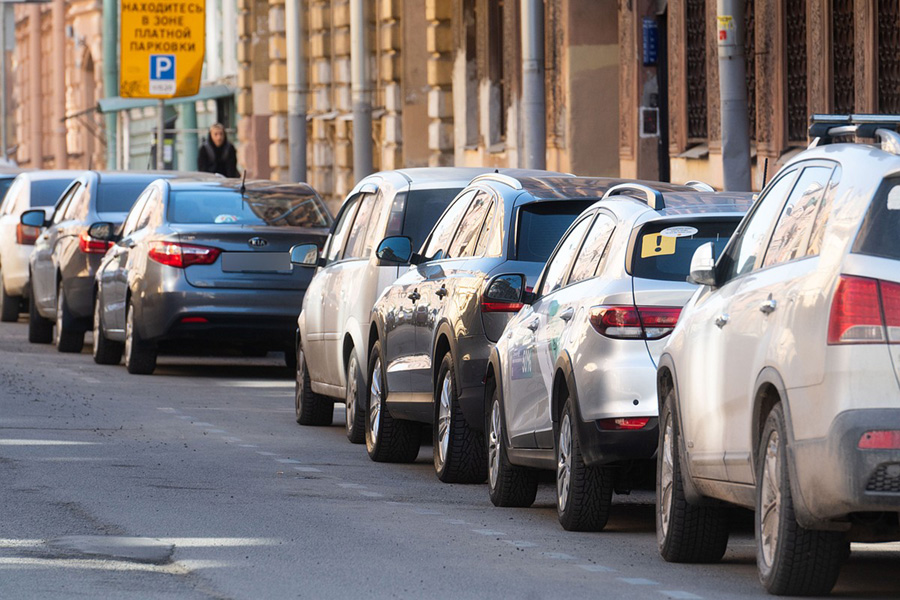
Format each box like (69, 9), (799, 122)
(657, 115), (900, 595)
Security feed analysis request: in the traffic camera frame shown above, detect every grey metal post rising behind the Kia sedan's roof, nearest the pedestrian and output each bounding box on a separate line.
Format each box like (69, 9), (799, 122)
(285, 0), (307, 181)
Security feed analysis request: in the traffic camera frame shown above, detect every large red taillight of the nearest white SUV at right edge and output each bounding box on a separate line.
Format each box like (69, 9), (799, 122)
(828, 275), (900, 345)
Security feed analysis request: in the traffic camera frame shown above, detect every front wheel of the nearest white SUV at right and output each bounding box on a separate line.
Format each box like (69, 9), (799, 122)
(656, 390), (729, 563)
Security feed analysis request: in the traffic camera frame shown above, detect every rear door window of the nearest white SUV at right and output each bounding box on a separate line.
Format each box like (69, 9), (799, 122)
(763, 167), (831, 267)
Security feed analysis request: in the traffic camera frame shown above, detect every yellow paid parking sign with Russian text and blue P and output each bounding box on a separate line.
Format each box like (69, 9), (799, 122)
(119, 0), (206, 98)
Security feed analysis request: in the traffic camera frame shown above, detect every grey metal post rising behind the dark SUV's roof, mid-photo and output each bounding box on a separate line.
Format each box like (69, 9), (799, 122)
(522, 0), (547, 169)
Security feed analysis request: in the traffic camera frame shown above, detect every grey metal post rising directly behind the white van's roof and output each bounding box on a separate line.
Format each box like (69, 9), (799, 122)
(350, 0), (372, 181)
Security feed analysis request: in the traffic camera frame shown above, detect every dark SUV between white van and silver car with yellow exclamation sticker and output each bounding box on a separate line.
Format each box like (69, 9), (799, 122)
(366, 172), (700, 482)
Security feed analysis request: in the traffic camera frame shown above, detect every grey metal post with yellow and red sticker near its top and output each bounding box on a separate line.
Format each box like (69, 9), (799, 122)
(717, 0), (752, 191)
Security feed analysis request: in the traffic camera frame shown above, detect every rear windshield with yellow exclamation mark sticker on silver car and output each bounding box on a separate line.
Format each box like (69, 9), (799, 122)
(631, 219), (740, 281)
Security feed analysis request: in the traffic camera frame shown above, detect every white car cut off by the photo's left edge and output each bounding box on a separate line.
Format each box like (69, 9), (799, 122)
(0, 171), (79, 322)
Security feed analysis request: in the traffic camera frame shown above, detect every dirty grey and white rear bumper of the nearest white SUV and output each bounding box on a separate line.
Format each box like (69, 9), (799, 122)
(790, 409), (900, 526)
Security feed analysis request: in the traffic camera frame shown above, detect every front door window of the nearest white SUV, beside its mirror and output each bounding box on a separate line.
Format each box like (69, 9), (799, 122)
(720, 170), (797, 281)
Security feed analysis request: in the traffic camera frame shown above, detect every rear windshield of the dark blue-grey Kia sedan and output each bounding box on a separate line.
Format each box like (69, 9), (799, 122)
(167, 190), (331, 227)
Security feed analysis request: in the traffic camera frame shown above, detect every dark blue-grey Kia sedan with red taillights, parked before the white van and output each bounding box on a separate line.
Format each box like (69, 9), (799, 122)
(88, 179), (332, 374)
